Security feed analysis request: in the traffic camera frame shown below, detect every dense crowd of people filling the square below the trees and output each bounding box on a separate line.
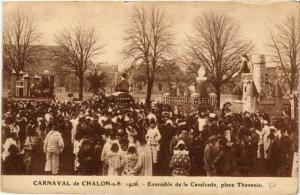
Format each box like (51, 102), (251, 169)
(2, 96), (298, 176)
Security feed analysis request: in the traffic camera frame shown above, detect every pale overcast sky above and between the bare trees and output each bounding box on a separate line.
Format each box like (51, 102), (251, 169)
(3, 2), (299, 70)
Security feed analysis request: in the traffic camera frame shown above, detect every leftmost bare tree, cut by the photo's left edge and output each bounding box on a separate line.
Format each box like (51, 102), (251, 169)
(3, 11), (40, 75)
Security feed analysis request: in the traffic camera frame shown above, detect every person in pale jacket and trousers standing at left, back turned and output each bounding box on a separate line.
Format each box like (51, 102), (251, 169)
(44, 121), (64, 175)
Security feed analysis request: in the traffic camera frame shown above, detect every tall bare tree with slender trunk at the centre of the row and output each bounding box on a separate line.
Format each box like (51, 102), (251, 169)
(123, 8), (173, 108)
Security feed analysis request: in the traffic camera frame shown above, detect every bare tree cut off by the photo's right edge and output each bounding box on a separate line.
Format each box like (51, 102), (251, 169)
(268, 15), (300, 94)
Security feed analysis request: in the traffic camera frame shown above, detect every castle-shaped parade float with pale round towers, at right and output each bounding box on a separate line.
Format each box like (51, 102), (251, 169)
(231, 55), (284, 115)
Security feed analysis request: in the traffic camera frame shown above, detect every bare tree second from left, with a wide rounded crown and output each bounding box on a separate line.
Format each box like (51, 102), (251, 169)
(52, 25), (103, 100)
